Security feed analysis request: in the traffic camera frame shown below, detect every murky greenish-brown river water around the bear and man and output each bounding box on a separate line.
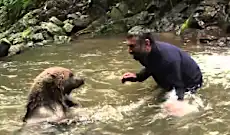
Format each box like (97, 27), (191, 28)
(0, 34), (230, 135)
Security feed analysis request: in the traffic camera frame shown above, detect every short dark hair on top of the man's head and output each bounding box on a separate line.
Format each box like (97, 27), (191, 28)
(126, 26), (155, 45)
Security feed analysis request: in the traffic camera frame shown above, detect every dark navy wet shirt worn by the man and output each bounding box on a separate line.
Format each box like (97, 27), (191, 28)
(136, 42), (202, 99)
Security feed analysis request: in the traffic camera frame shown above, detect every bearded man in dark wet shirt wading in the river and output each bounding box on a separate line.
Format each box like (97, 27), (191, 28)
(122, 26), (203, 100)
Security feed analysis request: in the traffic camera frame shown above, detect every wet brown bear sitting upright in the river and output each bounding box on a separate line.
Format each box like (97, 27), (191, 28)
(23, 67), (84, 123)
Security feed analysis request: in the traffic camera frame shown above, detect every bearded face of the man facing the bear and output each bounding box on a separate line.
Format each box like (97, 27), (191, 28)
(126, 37), (151, 59)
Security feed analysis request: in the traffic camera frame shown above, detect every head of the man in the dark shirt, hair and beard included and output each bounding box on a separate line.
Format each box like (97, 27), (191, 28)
(126, 26), (155, 59)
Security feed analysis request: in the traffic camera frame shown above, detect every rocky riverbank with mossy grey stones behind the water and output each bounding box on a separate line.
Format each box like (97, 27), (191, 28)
(0, 0), (230, 56)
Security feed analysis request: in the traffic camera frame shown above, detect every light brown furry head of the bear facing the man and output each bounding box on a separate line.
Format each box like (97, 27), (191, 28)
(32, 67), (84, 99)
